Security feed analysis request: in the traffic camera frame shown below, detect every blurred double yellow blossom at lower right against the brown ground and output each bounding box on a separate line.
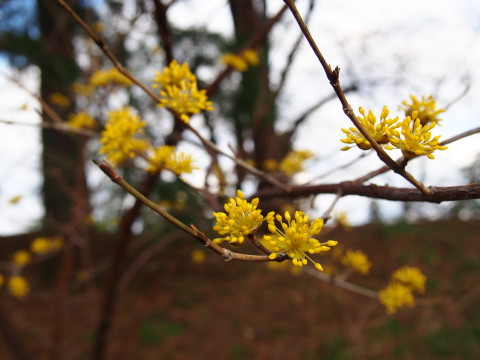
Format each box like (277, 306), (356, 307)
(378, 266), (427, 314)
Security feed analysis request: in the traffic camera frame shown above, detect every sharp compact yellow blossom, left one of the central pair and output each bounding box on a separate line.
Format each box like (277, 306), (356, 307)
(213, 190), (266, 245)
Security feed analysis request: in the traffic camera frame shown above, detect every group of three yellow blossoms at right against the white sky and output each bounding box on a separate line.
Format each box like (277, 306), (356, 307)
(341, 95), (447, 159)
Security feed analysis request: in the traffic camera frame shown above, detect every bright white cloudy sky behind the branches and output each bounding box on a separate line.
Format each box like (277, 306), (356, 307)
(0, 0), (480, 234)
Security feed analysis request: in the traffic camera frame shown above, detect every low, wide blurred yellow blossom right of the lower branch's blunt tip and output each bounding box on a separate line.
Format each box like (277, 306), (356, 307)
(146, 145), (198, 175)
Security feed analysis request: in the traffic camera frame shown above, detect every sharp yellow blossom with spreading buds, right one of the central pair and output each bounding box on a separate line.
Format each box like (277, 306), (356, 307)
(263, 211), (337, 271)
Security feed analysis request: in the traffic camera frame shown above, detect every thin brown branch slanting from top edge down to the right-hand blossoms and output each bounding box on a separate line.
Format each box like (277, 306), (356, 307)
(284, 0), (430, 194)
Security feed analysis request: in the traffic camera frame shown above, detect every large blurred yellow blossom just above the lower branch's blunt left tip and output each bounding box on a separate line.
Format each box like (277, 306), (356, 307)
(100, 108), (148, 165)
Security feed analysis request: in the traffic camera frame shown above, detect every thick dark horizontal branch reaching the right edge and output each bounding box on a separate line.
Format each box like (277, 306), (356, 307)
(252, 181), (480, 203)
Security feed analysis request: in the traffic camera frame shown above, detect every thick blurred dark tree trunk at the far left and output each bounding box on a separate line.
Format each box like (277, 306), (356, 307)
(37, 0), (89, 230)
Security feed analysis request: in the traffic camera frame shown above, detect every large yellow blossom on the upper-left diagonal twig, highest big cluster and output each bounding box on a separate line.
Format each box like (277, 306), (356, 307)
(153, 60), (213, 123)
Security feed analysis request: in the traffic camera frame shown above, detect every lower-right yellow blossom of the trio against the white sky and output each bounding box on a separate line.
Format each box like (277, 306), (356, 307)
(385, 111), (448, 159)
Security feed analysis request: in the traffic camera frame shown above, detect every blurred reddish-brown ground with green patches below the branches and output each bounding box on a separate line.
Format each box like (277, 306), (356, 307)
(0, 221), (480, 360)
